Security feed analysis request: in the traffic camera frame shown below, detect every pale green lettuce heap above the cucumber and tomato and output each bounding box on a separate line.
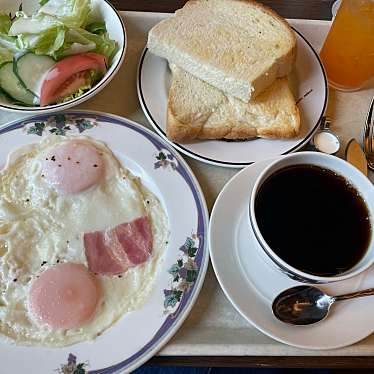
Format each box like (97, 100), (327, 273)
(0, 0), (118, 63)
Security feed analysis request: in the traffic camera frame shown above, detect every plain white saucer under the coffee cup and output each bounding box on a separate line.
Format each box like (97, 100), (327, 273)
(209, 159), (374, 350)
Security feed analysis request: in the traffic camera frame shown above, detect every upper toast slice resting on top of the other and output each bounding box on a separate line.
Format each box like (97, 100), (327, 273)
(148, 0), (296, 102)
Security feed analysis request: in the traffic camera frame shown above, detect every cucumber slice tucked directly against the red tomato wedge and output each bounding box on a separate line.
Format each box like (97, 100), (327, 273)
(13, 53), (56, 97)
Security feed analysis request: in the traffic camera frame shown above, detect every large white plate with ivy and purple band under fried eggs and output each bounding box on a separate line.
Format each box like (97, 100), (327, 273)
(0, 111), (209, 374)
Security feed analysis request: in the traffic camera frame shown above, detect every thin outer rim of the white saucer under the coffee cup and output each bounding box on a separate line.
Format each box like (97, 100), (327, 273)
(208, 155), (374, 351)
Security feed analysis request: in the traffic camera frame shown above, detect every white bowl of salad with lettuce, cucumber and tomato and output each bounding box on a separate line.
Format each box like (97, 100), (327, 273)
(0, 0), (127, 113)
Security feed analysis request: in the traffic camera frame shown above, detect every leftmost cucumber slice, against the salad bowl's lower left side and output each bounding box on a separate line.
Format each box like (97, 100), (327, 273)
(0, 62), (35, 105)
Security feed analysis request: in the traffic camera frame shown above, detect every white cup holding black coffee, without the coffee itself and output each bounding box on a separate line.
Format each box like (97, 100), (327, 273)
(249, 152), (374, 284)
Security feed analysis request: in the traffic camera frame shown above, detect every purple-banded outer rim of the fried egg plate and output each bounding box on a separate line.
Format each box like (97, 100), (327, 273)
(0, 109), (210, 374)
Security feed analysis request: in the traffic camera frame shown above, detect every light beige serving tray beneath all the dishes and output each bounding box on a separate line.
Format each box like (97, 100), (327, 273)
(0, 12), (374, 356)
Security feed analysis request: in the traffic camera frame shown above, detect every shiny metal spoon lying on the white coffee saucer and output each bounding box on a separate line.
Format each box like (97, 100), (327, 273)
(272, 286), (374, 325)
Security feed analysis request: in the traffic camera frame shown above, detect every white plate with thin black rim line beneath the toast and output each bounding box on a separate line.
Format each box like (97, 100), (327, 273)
(137, 29), (327, 168)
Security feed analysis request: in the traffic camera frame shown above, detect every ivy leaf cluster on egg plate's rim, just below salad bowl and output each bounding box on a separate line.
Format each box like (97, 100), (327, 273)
(24, 114), (97, 136)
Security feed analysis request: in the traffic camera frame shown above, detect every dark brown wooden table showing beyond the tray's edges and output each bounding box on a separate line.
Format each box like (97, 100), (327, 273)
(102, 0), (374, 368)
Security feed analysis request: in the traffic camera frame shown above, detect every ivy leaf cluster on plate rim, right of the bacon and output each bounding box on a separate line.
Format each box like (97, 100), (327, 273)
(164, 234), (199, 314)
